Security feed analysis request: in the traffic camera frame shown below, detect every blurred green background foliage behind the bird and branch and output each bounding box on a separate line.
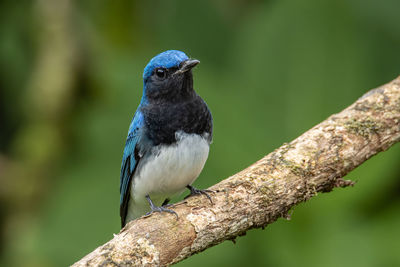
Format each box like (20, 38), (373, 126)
(0, 0), (400, 267)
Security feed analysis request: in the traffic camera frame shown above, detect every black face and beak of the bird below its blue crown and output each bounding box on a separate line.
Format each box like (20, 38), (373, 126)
(145, 60), (199, 102)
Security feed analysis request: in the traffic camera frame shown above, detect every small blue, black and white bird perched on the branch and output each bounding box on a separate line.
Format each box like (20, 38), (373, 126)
(120, 50), (213, 228)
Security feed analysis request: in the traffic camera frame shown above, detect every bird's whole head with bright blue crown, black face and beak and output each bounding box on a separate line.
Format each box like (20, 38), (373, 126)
(142, 50), (200, 102)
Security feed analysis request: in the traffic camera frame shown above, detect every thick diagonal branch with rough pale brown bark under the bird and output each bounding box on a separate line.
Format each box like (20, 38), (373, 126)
(73, 77), (400, 266)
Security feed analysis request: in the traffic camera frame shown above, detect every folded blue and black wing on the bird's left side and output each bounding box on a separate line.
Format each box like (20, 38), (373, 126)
(119, 108), (144, 227)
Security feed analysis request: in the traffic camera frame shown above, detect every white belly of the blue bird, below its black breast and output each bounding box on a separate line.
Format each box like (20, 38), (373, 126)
(127, 133), (209, 221)
